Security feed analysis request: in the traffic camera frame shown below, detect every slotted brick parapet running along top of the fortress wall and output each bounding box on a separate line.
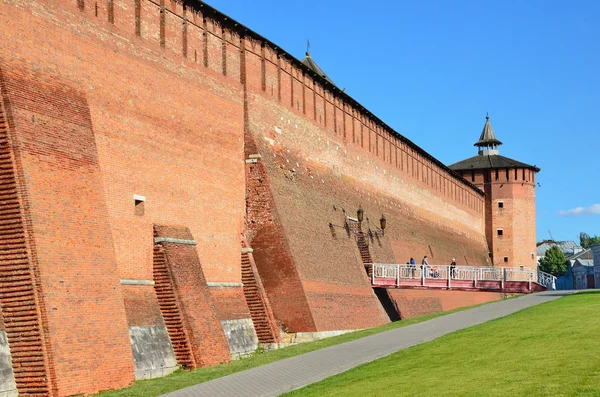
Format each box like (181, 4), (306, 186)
(65, 0), (484, 213)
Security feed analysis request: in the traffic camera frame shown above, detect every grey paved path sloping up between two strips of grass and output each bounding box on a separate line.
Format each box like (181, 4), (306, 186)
(164, 291), (574, 397)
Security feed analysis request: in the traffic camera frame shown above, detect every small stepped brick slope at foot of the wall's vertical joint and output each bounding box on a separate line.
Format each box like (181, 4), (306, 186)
(242, 249), (280, 343)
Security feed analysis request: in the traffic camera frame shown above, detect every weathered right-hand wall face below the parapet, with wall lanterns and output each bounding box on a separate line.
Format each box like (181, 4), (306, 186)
(249, 99), (487, 331)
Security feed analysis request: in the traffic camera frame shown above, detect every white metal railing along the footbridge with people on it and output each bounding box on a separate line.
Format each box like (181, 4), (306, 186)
(371, 263), (556, 290)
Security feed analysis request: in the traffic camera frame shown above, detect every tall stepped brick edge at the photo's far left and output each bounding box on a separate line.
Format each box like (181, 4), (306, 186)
(0, 86), (50, 396)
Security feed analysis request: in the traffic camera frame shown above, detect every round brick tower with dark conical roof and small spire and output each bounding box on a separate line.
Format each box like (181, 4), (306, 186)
(449, 116), (540, 268)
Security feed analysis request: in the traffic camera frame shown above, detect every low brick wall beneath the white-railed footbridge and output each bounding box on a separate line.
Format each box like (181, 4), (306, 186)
(387, 289), (504, 320)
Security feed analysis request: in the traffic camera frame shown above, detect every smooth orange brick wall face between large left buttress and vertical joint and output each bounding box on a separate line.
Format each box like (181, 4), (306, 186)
(0, 0), (244, 282)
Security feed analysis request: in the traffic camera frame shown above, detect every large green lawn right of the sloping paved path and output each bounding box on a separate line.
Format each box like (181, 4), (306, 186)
(285, 291), (600, 397)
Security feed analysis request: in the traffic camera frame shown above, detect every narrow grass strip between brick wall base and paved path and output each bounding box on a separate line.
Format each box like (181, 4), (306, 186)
(97, 306), (496, 397)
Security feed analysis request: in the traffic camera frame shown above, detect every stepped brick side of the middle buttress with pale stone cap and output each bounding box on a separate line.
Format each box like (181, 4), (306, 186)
(154, 244), (197, 368)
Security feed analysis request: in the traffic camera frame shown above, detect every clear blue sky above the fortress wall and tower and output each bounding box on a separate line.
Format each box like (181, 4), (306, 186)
(207, 0), (600, 241)
